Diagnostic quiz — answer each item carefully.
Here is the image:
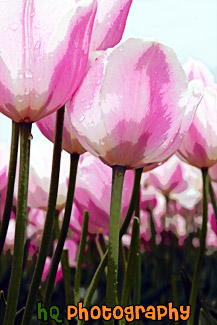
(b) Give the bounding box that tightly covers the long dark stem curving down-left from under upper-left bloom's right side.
[22,106,64,325]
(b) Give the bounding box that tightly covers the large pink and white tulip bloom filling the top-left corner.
[0,0,96,122]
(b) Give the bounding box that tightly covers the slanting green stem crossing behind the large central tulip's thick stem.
[81,168,142,308]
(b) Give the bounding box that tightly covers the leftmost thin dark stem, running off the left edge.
[0,121,19,257]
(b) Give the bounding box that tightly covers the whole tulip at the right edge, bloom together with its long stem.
[178,62,217,325]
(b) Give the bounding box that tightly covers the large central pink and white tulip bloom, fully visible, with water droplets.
[67,39,200,169]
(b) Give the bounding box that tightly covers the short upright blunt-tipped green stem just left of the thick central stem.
[74,210,89,305]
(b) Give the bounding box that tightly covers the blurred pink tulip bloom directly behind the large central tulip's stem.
[73,154,134,233]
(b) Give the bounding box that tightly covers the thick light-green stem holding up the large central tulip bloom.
[106,166,125,316]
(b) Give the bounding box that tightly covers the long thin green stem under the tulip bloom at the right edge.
[188,168,209,325]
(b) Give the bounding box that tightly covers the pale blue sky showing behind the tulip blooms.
[0,0,217,142]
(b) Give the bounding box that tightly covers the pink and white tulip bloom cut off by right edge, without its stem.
[178,62,217,168]
